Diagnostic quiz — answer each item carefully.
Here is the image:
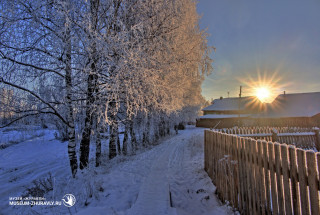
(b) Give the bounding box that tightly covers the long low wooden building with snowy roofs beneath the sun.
[197,92,320,128]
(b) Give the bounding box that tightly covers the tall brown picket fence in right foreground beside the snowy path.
[204,130,320,215]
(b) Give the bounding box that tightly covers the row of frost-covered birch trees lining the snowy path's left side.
[0,0,212,176]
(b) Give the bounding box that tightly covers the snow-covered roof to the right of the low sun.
[257,92,320,118]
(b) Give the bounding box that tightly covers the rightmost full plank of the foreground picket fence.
[306,151,320,214]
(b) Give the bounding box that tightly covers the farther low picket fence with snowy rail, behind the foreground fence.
[216,127,320,152]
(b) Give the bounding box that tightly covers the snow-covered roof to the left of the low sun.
[202,96,260,111]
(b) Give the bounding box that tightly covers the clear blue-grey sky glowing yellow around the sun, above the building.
[197,0,320,100]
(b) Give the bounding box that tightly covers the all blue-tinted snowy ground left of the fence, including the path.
[0,128,233,215]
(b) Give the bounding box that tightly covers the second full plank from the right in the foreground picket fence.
[297,149,309,214]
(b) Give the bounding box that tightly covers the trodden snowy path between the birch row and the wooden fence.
[127,129,231,215]
